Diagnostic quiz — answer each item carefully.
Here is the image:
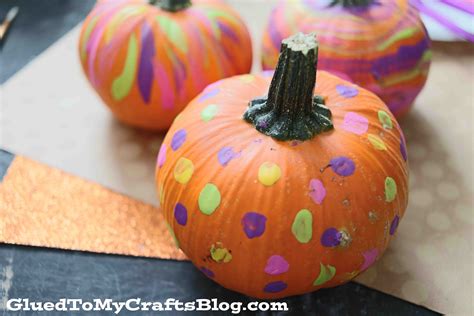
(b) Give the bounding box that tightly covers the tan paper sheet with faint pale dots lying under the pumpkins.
[0,2,474,315]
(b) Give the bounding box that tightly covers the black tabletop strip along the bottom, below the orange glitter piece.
[0,245,436,315]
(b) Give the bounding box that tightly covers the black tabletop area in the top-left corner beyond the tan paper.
[0,0,95,84]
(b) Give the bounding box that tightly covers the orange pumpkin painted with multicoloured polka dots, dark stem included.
[156,33,408,298]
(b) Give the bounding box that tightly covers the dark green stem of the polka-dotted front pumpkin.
[244,33,333,140]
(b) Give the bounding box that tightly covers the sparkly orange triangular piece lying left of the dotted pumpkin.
[0,156,186,260]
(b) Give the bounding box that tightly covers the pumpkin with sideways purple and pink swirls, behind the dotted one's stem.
[262,0,431,117]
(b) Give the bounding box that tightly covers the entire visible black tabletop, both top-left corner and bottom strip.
[0,0,437,315]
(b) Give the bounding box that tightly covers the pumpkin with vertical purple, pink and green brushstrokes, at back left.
[79,0,252,130]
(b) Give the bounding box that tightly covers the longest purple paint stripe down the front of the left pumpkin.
[137,22,155,103]
